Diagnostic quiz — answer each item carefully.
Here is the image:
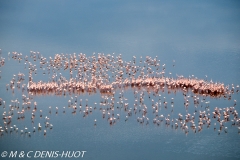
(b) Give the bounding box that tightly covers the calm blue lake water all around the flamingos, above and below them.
[0,1,240,159]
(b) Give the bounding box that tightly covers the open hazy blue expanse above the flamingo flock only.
[0,1,240,83]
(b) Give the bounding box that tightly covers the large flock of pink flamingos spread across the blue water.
[0,51,240,137]
